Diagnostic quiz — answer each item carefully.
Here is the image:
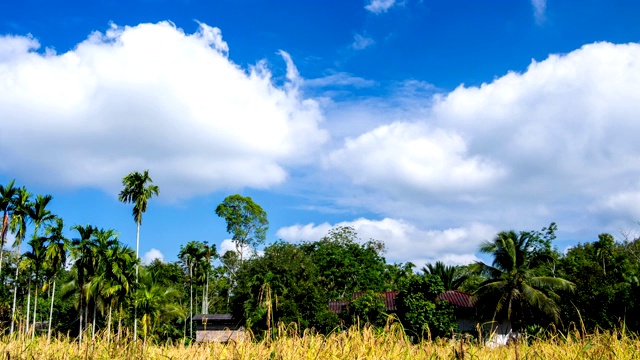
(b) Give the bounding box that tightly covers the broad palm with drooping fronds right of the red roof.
[474,231,574,330]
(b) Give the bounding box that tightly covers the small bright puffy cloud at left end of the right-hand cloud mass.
[326,122,505,197]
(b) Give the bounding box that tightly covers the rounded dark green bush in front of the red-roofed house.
[396,274,457,340]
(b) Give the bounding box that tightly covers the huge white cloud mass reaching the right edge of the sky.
[324,43,640,239]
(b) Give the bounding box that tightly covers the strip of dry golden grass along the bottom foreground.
[0,324,640,360]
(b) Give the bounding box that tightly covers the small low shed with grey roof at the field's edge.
[191,314,244,342]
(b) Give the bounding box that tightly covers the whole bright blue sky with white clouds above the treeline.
[0,0,640,267]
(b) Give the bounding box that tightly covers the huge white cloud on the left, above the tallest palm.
[0,22,328,199]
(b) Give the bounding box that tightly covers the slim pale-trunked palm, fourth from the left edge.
[46,218,68,343]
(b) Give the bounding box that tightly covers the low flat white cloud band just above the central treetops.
[277,218,497,267]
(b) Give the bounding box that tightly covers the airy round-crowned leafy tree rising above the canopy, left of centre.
[216,194,269,263]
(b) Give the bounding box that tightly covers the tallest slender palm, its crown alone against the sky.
[118,170,160,339]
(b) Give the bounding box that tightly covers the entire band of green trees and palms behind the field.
[0,171,640,343]
